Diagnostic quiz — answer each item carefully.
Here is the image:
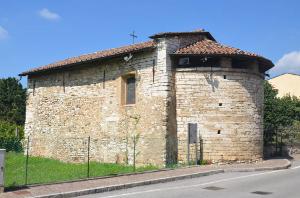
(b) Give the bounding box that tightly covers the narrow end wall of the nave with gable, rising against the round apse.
[156,35,205,164]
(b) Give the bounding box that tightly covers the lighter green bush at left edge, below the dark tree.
[0,120,24,152]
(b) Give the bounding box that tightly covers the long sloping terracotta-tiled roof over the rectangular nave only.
[19,41,156,76]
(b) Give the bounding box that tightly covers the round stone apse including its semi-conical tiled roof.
[173,39,273,162]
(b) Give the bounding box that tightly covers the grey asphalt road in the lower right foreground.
[81,161,300,198]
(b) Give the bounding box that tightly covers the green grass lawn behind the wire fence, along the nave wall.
[4,152,157,187]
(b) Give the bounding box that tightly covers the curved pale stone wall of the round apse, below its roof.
[176,68,263,162]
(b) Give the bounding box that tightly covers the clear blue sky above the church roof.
[0,0,300,84]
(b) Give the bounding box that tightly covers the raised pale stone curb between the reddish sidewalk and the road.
[35,169,224,198]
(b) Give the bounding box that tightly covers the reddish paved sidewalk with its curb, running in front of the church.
[0,159,291,198]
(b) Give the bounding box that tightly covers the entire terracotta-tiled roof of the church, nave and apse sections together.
[19,30,274,76]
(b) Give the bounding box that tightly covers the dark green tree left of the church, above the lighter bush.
[0,78,26,125]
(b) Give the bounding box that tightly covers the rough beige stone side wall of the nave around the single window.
[25,51,171,165]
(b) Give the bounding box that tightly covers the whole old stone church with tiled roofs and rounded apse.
[20,30,273,166]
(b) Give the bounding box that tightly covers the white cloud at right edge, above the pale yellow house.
[270,51,300,75]
